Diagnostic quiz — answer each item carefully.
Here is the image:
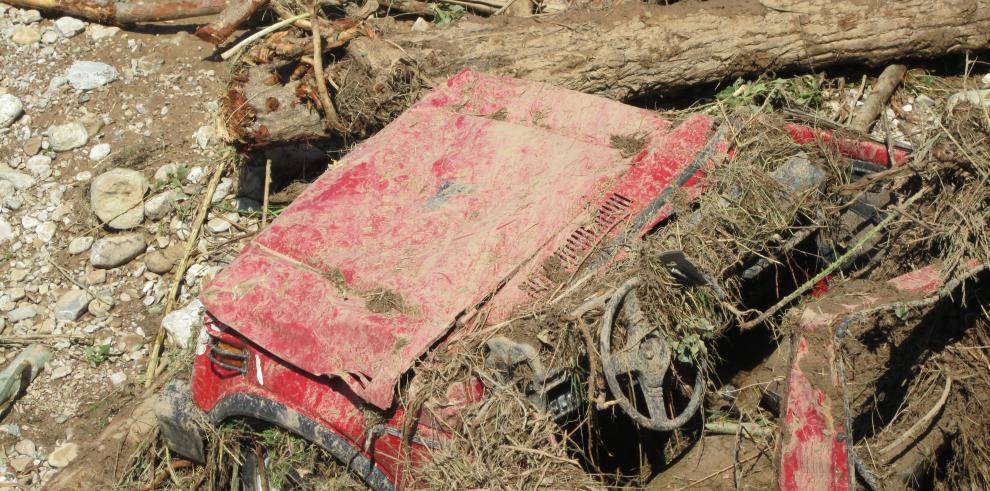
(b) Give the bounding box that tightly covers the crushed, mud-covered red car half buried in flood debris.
[156,70,905,489]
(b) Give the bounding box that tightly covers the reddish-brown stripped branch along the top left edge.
[4,0,227,24]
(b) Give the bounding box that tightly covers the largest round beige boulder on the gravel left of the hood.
[89,168,149,230]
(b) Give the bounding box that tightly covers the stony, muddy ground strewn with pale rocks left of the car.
[0,4,244,487]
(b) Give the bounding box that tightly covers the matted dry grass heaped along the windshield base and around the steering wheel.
[396,109,844,489]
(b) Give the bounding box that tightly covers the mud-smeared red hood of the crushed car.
[201,71,707,407]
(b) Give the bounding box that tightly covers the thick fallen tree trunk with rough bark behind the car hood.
[224,0,990,145]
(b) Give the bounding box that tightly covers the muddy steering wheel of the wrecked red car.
[599,278,705,431]
